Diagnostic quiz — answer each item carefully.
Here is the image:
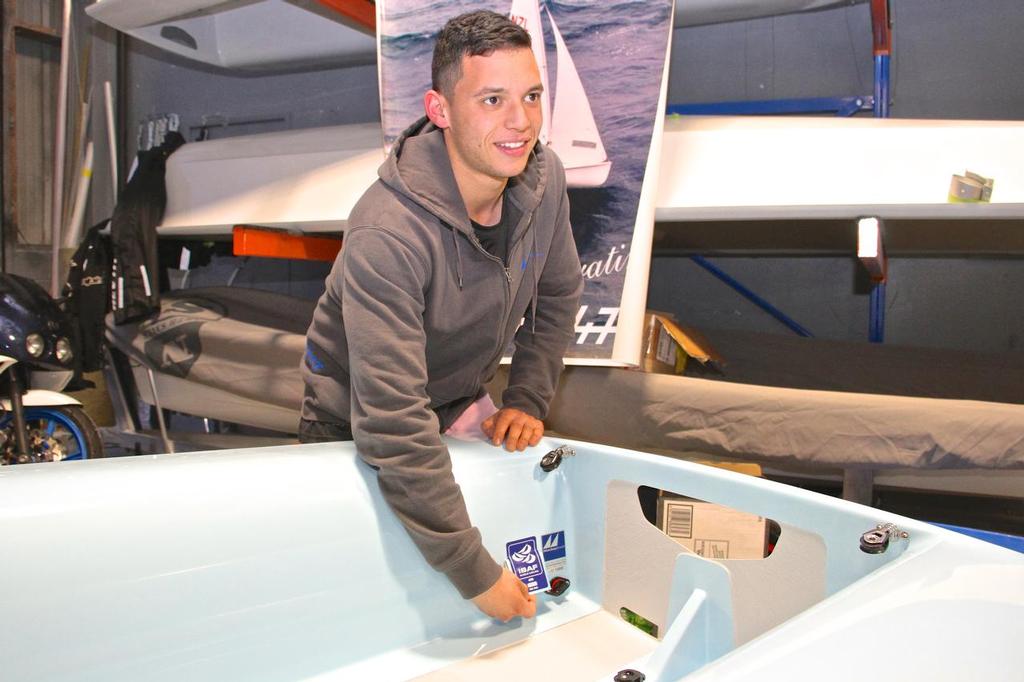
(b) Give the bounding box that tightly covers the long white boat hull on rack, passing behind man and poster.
[149,116,1024,237]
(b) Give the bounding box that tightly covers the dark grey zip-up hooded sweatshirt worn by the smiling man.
[302,118,583,598]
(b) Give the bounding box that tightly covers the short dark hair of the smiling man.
[430,9,530,97]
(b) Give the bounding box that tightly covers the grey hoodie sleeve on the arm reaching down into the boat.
[342,228,502,599]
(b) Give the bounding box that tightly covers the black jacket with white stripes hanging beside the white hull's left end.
[111,132,185,325]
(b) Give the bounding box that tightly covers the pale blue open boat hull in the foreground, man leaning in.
[0,438,1024,682]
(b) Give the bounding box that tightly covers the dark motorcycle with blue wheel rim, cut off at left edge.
[0,273,103,465]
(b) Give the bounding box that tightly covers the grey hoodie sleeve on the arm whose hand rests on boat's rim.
[502,176,583,419]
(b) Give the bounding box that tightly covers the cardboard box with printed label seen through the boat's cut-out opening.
[657,491,768,559]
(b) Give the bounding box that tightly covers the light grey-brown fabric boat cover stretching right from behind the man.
[547,368,1024,469]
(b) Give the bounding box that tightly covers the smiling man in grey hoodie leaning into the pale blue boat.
[299,11,583,621]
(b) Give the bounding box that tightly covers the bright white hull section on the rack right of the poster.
[656,116,1024,222]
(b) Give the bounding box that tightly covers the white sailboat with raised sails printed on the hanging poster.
[509,0,611,187]
